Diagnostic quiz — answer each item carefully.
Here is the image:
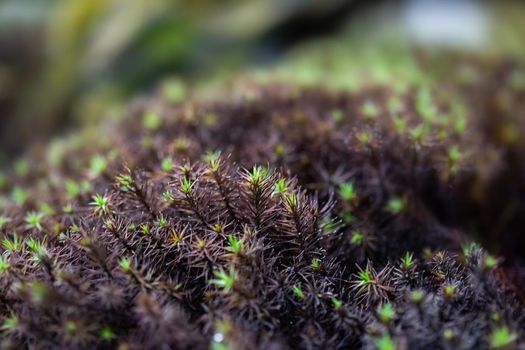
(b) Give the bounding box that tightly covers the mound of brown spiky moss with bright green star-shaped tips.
[0,82,525,349]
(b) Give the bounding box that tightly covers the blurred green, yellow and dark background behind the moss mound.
[0,0,525,161]
